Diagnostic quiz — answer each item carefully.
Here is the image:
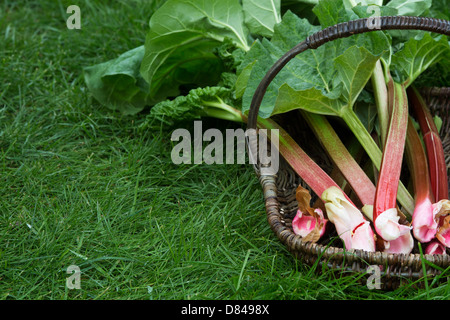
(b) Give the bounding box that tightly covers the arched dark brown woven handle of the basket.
[247,16,450,130]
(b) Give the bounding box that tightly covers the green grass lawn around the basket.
[0,0,450,299]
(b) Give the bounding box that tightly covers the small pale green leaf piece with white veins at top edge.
[242,0,281,38]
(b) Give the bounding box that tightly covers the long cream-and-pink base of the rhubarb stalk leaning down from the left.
[321,187,375,252]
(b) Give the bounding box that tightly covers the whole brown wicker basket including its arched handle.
[248,17,450,290]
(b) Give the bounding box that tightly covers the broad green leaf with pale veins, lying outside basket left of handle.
[141,0,248,99]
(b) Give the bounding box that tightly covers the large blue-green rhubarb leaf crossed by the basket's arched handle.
[236,0,389,118]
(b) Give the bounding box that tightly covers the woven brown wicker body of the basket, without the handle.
[258,88,450,290]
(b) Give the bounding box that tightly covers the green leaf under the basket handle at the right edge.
[390,33,450,87]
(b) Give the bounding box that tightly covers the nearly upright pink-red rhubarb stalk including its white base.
[373,82,413,253]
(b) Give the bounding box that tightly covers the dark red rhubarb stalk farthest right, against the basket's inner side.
[407,87,448,201]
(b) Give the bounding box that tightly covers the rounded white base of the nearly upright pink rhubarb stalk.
[374,208,411,241]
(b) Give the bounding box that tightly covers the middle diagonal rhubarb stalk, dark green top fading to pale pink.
[302,111,376,205]
